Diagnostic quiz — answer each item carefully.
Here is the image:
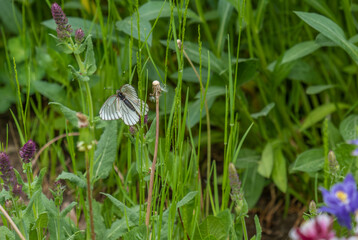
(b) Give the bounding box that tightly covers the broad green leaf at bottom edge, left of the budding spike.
[194,209,232,240]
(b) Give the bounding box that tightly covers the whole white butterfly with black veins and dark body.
[99,84,149,126]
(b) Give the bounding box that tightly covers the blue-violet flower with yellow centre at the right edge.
[319,174,358,229]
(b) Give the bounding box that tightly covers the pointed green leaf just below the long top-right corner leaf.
[267,41,321,71]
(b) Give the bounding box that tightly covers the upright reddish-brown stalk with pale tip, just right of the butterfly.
[145,81,161,229]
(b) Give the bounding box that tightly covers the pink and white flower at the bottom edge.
[289,214,338,240]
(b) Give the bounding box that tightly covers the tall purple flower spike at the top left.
[51,3,72,40]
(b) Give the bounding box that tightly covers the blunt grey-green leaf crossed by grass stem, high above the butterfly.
[116,17,153,46]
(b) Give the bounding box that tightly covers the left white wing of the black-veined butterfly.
[99,95,122,120]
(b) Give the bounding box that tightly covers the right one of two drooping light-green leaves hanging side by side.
[272,148,287,193]
